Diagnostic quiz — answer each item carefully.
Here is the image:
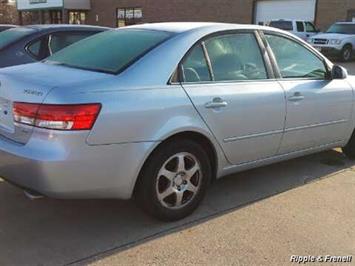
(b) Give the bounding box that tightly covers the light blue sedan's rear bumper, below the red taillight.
[0,129,154,199]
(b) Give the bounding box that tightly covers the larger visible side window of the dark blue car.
[48,32,95,54]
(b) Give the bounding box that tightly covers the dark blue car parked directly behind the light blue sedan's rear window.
[0,25,109,67]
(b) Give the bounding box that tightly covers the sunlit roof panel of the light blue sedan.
[125,22,280,33]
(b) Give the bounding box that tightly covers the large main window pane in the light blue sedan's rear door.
[205,33,267,81]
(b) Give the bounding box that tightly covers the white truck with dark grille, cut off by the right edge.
[308,22,355,62]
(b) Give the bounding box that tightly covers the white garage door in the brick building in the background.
[255,0,316,24]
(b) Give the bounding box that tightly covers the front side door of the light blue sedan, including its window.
[265,33,353,154]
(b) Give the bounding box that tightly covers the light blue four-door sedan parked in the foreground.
[0,23,355,220]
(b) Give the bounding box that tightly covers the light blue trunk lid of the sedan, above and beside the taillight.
[0,63,111,144]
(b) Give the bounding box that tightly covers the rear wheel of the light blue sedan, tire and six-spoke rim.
[135,139,212,221]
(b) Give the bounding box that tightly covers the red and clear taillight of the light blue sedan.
[13,102,101,130]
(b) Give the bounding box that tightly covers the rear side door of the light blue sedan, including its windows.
[180,32,286,164]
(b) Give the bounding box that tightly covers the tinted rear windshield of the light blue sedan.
[46,29,171,74]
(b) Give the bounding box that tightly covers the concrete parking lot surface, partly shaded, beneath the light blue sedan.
[0,63,355,265]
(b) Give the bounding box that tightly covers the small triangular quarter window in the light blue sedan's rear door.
[182,45,211,82]
